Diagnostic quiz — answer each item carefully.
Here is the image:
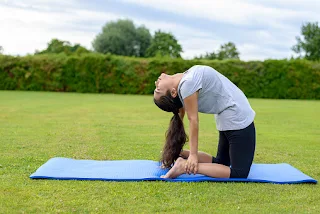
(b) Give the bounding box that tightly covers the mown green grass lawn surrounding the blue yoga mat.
[0,91,320,213]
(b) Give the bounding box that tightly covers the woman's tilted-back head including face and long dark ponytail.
[154,74,187,168]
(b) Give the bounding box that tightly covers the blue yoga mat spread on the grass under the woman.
[30,158,317,184]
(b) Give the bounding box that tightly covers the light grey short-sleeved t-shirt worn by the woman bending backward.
[178,65,255,131]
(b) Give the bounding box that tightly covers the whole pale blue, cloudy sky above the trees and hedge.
[0,0,320,61]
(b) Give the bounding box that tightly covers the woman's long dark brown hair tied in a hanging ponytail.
[154,91,188,168]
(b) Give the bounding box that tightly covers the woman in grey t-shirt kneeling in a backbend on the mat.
[154,65,256,178]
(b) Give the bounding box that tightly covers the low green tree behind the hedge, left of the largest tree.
[35,39,90,55]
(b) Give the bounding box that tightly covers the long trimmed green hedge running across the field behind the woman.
[0,54,320,99]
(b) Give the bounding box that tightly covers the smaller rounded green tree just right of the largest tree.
[147,30,182,58]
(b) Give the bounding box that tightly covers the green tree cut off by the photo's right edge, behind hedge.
[292,22,320,60]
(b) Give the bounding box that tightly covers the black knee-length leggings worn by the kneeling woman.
[212,122,256,178]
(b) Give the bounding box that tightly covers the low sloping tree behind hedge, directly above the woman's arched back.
[196,42,239,60]
